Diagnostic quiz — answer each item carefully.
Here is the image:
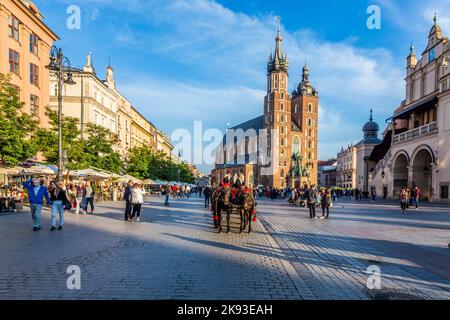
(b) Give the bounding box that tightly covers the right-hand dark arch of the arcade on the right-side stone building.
[412,148,433,200]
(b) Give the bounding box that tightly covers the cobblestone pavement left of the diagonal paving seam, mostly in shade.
[0,198,302,299]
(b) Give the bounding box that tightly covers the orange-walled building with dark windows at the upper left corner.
[0,0,58,127]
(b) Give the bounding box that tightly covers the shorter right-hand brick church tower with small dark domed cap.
[292,62,319,185]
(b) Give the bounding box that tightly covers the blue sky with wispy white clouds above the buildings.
[34,0,450,172]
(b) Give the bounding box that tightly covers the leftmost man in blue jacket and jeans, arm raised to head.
[23,178,51,231]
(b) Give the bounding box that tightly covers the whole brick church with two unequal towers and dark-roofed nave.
[212,26,319,188]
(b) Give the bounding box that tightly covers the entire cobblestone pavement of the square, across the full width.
[0,198,450,299]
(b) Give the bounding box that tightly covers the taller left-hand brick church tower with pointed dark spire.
[260,21,291,188]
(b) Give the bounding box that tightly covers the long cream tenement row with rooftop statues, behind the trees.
[49,53,173,158]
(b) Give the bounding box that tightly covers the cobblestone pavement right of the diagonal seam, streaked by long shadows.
[260,201,450,299]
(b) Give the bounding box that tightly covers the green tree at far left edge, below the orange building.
[0,74,37,166]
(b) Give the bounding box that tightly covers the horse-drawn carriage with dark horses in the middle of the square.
[211,183,256,233]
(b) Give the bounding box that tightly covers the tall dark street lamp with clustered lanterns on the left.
[46,46,76,181]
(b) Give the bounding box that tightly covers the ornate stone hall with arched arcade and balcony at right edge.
[369,16,450,202]
